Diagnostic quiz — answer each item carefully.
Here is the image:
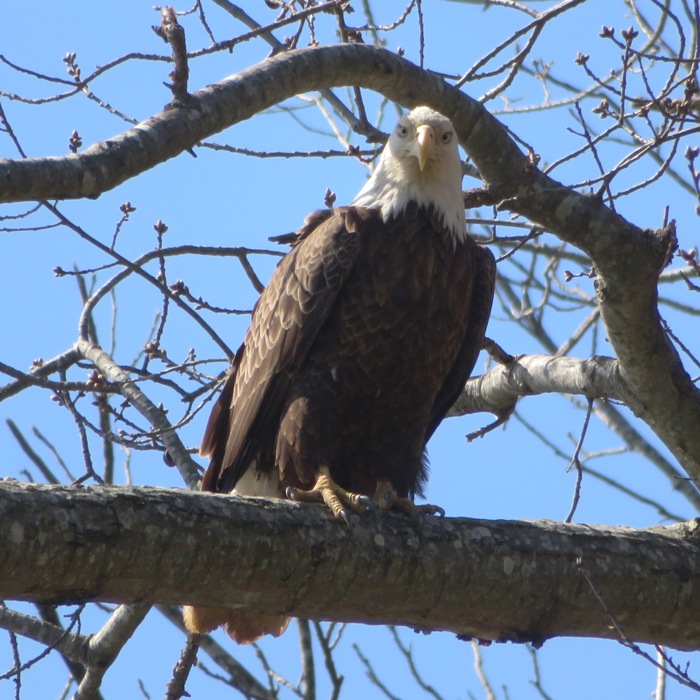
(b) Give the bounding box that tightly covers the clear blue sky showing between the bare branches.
[0,0,700,700]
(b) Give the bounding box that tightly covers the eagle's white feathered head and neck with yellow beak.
[352,107,466,241]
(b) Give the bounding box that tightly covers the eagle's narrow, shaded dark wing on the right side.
[425,239,496,442]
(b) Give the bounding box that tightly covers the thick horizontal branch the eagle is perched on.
[0,481,700,649]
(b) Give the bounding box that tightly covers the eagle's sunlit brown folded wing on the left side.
[200,207,363,493]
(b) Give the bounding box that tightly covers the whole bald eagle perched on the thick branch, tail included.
[185,107,495,643]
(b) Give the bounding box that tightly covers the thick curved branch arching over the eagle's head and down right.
[0,44,700,480]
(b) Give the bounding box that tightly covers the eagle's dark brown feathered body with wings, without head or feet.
[203,206,492,504]
